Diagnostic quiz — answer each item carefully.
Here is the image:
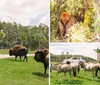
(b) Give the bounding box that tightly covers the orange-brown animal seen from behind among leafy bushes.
[56,12,77,40]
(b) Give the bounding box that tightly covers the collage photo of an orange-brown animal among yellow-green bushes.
[50,0,100,43]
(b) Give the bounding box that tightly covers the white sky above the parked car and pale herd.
[50,43,100,59]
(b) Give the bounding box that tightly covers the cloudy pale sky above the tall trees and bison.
[0,0,50,26]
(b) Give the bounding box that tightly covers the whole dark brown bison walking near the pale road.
[9,45,28,62]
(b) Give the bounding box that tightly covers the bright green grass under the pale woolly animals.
[50,63,100,85]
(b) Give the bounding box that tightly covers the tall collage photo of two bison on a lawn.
[0,0,50,85]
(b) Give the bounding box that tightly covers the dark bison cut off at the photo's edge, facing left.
[34,49,49,74]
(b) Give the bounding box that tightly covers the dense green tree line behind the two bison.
[0,22,49,49]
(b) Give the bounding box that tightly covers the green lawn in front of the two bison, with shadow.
[0,57,48,85]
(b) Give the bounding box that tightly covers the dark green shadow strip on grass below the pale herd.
[55,80,84,85]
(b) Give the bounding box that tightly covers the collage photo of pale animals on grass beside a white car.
[50,43,100,85]
